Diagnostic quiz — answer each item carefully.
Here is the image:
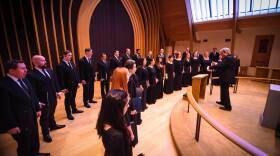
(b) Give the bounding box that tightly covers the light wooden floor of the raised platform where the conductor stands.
[171,80,280,156]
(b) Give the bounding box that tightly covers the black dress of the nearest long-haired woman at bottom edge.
[102,128,132,156]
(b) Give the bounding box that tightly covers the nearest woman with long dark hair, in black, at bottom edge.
[96,89,132,156]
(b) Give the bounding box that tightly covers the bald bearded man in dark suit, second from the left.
[27,55,65,142]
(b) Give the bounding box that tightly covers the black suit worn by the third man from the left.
[57,61,79,115]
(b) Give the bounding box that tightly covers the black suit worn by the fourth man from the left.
[79,57,96,105]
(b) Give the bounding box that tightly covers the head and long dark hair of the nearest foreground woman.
[96,89,129,137]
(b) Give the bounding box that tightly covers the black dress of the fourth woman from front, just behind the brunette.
[136,67,149,111]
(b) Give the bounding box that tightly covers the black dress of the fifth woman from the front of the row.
[147,67,157,104]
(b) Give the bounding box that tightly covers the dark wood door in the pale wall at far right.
[251,35,274,67]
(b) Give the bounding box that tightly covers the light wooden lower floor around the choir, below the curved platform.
[0,83,178,156]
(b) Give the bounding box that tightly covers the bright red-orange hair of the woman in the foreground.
[111,67,129,91]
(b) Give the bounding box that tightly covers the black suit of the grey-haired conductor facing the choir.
[217,55,235,109]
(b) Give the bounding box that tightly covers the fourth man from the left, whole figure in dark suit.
[79,48,96,108]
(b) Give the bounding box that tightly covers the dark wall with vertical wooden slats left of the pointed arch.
[0,0,81,77]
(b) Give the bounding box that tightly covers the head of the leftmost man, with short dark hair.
[6,60,27,79]
